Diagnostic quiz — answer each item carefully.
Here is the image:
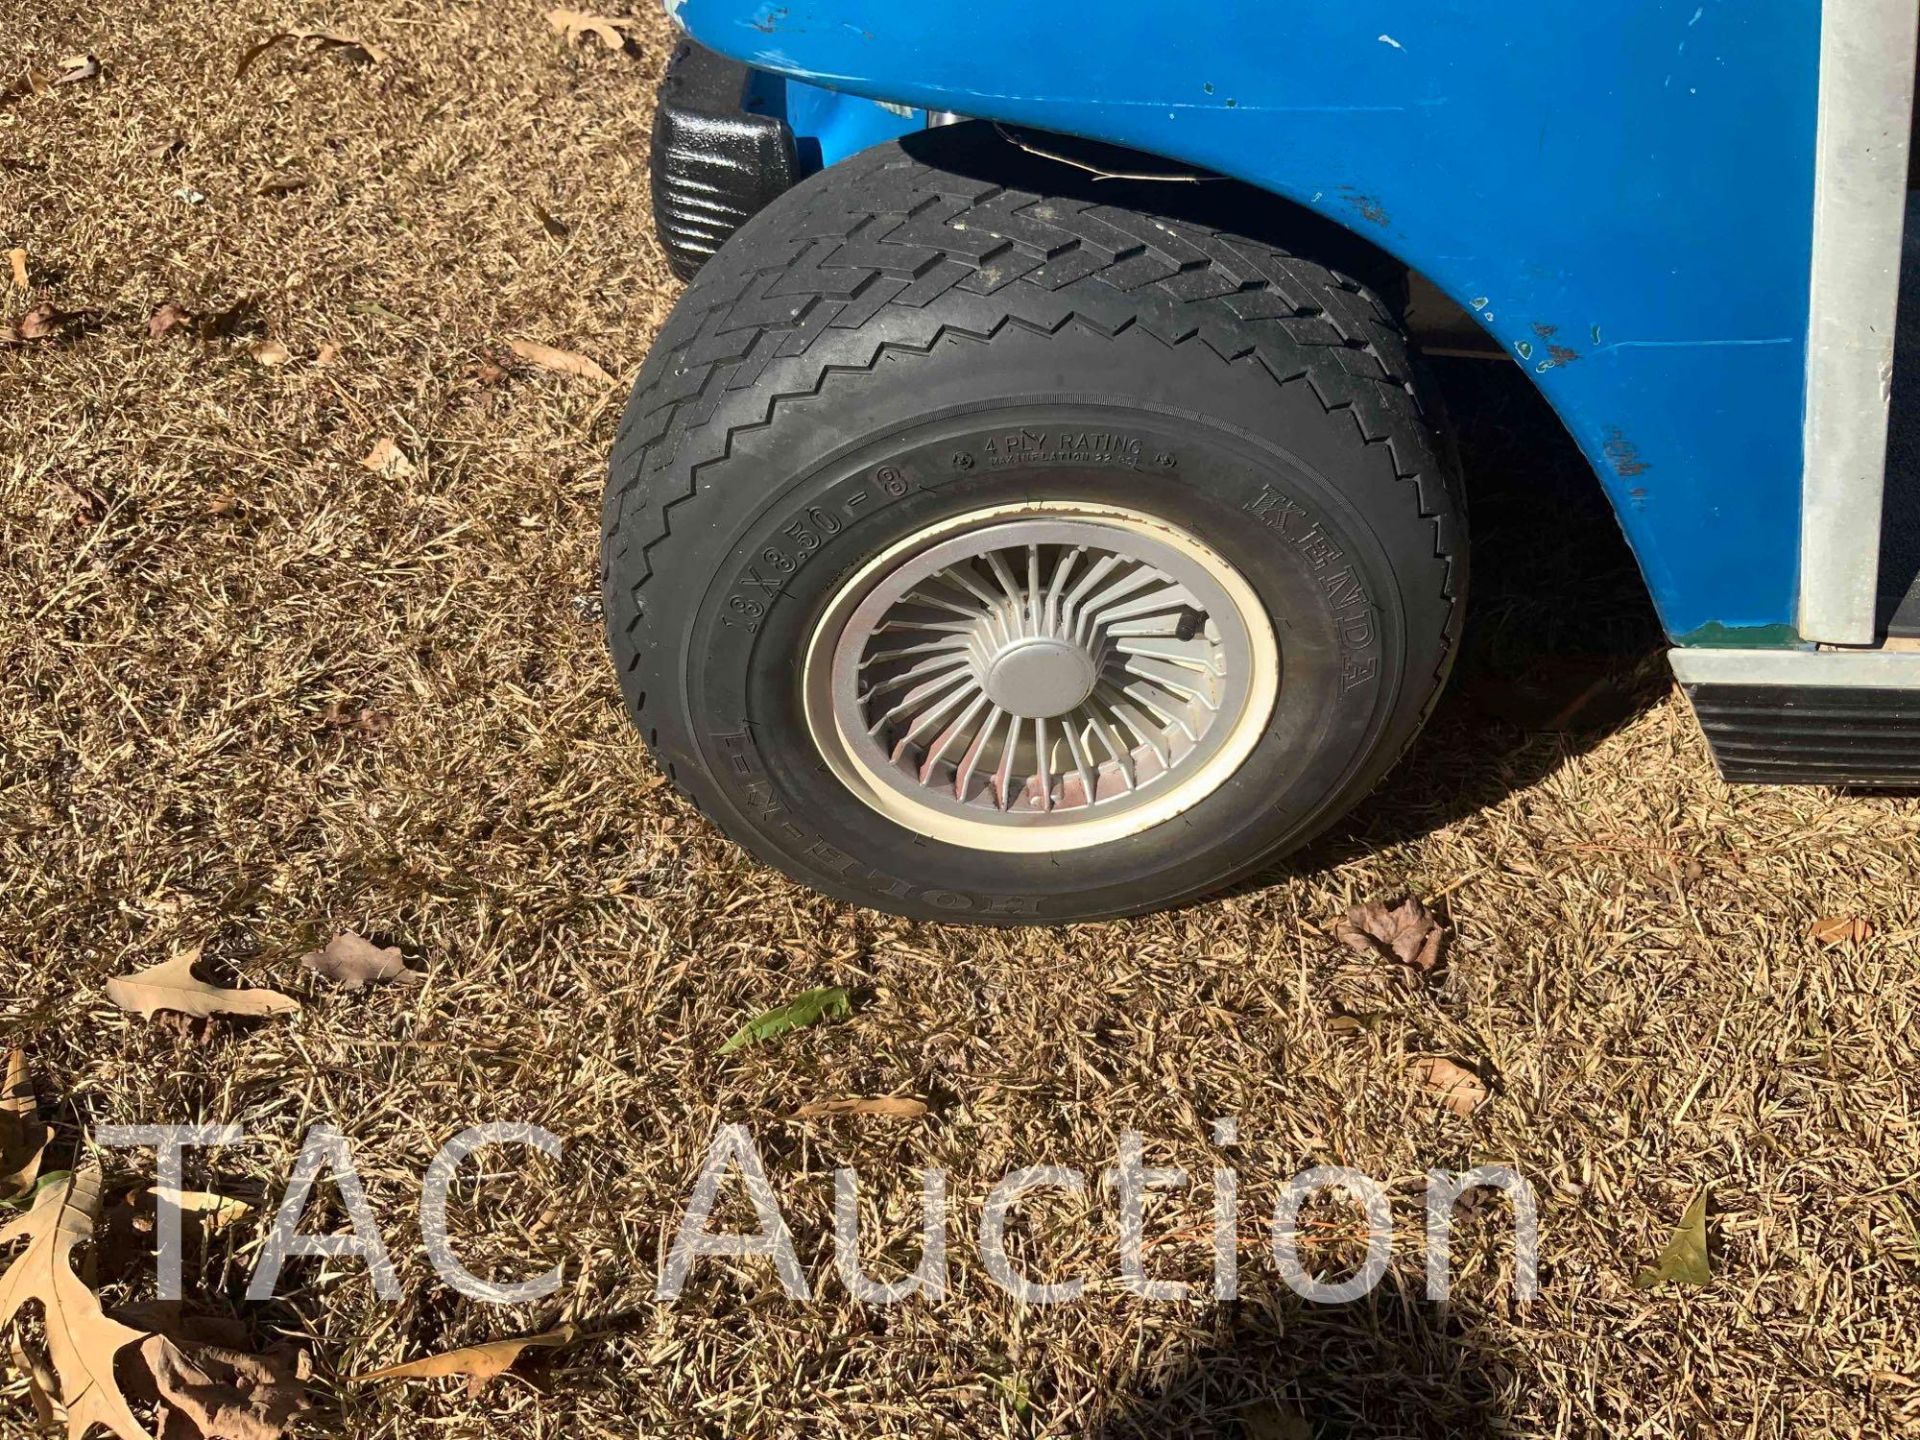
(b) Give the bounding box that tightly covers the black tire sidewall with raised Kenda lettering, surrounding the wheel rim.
[647,338,1430,922]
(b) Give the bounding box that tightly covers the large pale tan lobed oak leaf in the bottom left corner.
[0,1165,152,1440]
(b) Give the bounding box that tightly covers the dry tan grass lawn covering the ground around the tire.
[0,0,1920,1440]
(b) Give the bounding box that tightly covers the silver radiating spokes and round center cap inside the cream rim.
[825,511,1277,849]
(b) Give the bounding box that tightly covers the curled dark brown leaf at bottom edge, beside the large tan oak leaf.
[140,1334,309,1440]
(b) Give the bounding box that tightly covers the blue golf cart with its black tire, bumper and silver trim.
[605,0,1920,924]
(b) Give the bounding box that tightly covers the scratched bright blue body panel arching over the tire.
[680,0,1820,636]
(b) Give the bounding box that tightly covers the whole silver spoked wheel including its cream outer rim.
[804,503,1279,852]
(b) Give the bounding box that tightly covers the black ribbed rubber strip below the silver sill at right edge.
[1686,685,1920,789]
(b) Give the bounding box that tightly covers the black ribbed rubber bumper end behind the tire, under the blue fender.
[653,40,797,280]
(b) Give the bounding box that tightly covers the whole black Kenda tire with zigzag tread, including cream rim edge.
[603,123,1467,924]
